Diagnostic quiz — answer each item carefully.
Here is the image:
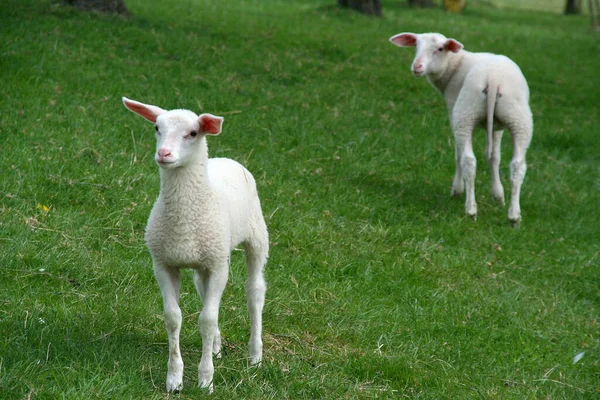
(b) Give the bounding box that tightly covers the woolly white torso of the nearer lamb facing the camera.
[146,158,266,269]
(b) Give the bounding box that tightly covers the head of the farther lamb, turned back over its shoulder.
[390,32,463,77]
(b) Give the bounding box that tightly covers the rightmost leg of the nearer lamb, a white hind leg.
[246,242,268,365]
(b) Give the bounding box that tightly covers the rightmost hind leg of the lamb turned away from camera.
[508,118,533,226]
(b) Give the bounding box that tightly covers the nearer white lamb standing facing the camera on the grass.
[123,97,269,392]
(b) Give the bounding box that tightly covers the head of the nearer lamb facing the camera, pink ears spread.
[123,97,223,169]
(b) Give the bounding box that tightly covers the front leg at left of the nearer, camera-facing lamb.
[154,263,183,392]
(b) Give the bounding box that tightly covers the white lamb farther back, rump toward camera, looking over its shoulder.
[390,33,533,225]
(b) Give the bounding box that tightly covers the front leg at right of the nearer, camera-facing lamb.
[198,261,229,393]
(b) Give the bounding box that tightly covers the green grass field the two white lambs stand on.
[0,0,600,399]
